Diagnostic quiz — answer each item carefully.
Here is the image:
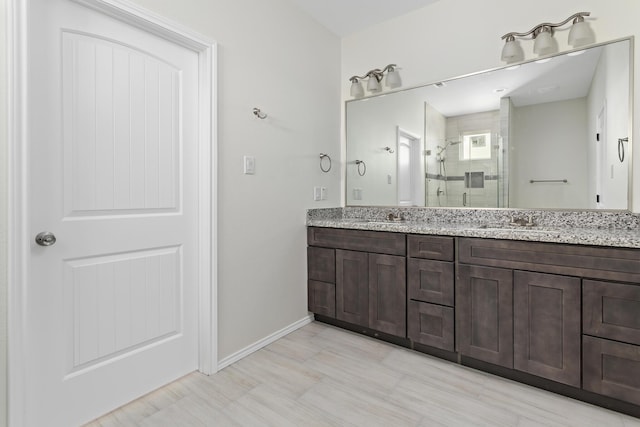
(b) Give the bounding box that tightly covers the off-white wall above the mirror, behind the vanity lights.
[341,0,640,212]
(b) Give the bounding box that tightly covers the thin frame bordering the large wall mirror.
[343,35,635,212]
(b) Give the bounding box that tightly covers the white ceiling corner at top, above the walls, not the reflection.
[289,0,439,37]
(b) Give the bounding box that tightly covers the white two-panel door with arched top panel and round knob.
[13,0,214,426]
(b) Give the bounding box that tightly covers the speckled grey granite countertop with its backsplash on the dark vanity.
[307,207,640,248]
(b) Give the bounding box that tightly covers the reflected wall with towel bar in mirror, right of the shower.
[509,98,591,209]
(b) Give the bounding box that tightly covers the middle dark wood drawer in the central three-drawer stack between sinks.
[407,258,454,306]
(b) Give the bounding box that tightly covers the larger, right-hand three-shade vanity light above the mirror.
[502,12,595,64]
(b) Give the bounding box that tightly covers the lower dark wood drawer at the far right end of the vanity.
[582,335,640,405]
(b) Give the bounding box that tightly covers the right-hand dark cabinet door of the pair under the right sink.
[513,271,581,387]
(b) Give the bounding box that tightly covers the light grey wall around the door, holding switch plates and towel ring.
[0,0,342,425]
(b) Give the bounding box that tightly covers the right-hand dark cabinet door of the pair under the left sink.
[369,254,407,337]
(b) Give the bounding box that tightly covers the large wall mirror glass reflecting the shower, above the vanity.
[346,38,633,210]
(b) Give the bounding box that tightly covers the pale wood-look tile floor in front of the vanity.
[88,322,640,427]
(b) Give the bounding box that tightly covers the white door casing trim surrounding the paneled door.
[6,0,218,426]
